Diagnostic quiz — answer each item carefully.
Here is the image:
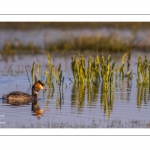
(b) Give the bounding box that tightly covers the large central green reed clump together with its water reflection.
[71,54,115,118]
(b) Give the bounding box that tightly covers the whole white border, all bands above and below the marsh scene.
[0,0,150,150]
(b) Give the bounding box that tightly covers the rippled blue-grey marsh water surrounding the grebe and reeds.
[0,27,150,128]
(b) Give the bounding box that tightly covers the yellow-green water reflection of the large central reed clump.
[71,79,114,118]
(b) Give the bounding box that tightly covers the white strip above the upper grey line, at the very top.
[0,0,149,14]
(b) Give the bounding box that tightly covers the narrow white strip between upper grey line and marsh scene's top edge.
[0,15,150,22]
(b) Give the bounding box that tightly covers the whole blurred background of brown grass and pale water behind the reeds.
[0,22,150,56]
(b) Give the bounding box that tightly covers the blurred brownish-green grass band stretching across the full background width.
[0,33,150,59]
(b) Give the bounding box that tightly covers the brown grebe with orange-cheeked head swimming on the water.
[2,80,46,107]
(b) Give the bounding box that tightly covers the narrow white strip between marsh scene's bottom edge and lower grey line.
[0,128,150,136]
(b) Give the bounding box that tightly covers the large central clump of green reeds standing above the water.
[71,54,115,90]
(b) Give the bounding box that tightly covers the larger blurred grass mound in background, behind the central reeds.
[45,35,132,52]
